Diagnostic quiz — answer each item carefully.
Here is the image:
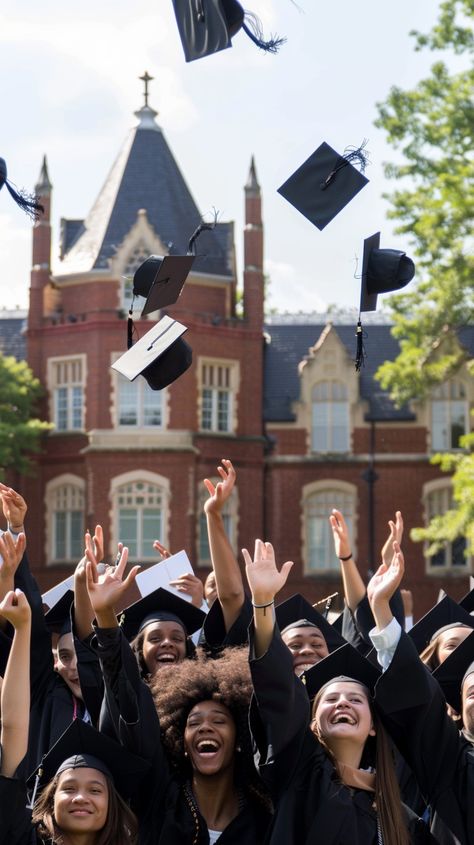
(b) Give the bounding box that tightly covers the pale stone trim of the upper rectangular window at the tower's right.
[197,356,240,435]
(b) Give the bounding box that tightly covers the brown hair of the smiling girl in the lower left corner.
[32,775,138,845]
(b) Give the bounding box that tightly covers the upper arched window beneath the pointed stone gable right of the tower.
[311,381,349,452]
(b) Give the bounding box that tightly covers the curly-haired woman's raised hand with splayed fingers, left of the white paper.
[86,546,140,628]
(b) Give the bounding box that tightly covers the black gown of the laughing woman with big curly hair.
[96,628,270,845]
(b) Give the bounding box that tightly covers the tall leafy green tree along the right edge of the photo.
[377,0,474,554]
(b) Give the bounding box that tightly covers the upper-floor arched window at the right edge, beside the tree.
[431,379,469,451]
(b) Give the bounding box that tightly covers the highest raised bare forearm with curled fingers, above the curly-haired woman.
[204,458,245,631]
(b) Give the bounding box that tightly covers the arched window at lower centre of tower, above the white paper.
[113,471,169,561]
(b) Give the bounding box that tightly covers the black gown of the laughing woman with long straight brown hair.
[250,629,432,845]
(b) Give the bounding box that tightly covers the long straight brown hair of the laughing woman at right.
[313,679,410,845]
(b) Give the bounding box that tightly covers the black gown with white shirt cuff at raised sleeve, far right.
[375,632,474,845]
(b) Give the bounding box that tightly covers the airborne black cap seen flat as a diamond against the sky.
[278,142,369,232]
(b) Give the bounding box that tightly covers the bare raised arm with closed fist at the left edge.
[0,590,31,777]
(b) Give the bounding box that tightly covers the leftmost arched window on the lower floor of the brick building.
[46,475,85,563]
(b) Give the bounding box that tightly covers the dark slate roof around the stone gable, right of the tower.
[263,317,415,422]
